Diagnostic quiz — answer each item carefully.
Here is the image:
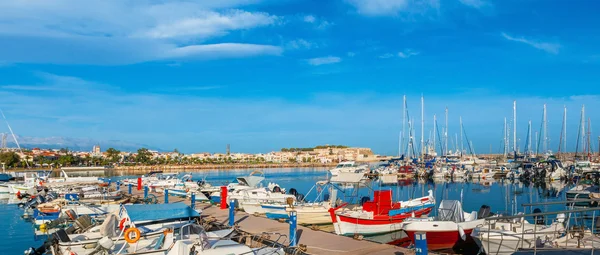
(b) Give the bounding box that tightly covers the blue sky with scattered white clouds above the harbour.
[0,0,600,154]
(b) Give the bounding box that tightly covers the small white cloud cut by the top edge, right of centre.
[347,0,440,16]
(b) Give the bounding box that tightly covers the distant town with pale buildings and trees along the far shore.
[0,145,388,168]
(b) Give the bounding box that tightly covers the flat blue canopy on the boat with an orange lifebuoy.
[120,203,200,222]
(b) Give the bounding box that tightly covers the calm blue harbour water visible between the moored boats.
[0,168,570,254]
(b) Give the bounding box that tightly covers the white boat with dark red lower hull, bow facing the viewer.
[403,200,492,250]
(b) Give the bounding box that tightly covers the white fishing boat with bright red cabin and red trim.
[329,190,435,235]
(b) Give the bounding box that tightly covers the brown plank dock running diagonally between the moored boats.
[128,187,415,255]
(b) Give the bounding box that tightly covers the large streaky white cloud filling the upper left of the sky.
[0,0,282,65]
